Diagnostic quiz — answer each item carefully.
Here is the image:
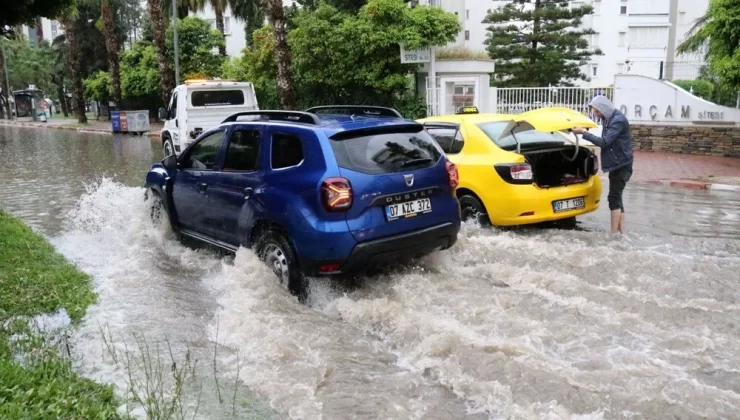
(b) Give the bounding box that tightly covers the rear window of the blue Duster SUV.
[331,130,442,174]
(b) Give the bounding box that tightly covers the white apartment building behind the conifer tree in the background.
[416,0,709,87]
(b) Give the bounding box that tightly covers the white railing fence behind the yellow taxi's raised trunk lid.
[490,86,614,115]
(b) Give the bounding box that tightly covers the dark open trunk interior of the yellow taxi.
[522,145,598,188]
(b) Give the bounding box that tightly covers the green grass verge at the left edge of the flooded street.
[0,211,125,419]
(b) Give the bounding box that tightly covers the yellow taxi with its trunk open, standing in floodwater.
[419,107,601,226]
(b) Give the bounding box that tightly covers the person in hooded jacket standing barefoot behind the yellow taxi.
[573,95,634,233]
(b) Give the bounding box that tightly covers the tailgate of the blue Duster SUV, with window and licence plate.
[330,123,452,242]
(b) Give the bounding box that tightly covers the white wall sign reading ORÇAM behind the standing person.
[614,75,740,125]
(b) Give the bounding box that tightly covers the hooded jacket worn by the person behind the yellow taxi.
[583,95,633,172]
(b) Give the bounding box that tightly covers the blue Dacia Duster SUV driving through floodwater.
[146,106,460,299]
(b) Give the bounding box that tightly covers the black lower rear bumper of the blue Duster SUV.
[301,223,460,275]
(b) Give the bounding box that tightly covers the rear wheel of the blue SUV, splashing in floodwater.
[256,230,308,303]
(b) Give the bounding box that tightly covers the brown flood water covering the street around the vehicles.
[0,126,740,419]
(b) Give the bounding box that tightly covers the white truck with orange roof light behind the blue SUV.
[159,79,259,157]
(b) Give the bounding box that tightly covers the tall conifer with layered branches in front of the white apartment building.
[483,0,601,87]
